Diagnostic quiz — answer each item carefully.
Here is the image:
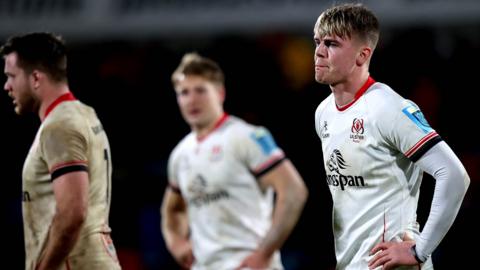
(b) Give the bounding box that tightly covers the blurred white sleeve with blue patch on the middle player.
[235,127,285,177]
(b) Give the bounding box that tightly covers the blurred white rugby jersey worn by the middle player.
[168,114,285,270]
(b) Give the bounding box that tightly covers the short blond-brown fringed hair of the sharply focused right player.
[314,3,380,49]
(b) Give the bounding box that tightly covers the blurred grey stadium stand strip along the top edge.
[0,0,480,40]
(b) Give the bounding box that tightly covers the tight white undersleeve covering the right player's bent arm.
[416,142,470,261]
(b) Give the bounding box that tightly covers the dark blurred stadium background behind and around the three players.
[0,0,480,270]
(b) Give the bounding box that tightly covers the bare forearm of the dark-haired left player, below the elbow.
[37,213,85,270]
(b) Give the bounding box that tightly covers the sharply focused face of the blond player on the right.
[314,33,359,85]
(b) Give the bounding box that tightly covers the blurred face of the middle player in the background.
[175,75,224,130]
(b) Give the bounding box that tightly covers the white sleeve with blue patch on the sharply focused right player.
[380,100,442,162]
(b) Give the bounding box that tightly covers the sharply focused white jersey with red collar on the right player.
[315,78,441,270]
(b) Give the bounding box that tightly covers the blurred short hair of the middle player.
[172,52,225,86]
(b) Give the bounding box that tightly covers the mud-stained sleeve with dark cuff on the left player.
[40,121,88,181]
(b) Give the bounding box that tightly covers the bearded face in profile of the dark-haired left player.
[4,53,39,115]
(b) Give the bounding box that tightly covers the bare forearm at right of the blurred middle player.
[259,182,308,256]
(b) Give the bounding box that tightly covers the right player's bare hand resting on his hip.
[368,241,418,270]
